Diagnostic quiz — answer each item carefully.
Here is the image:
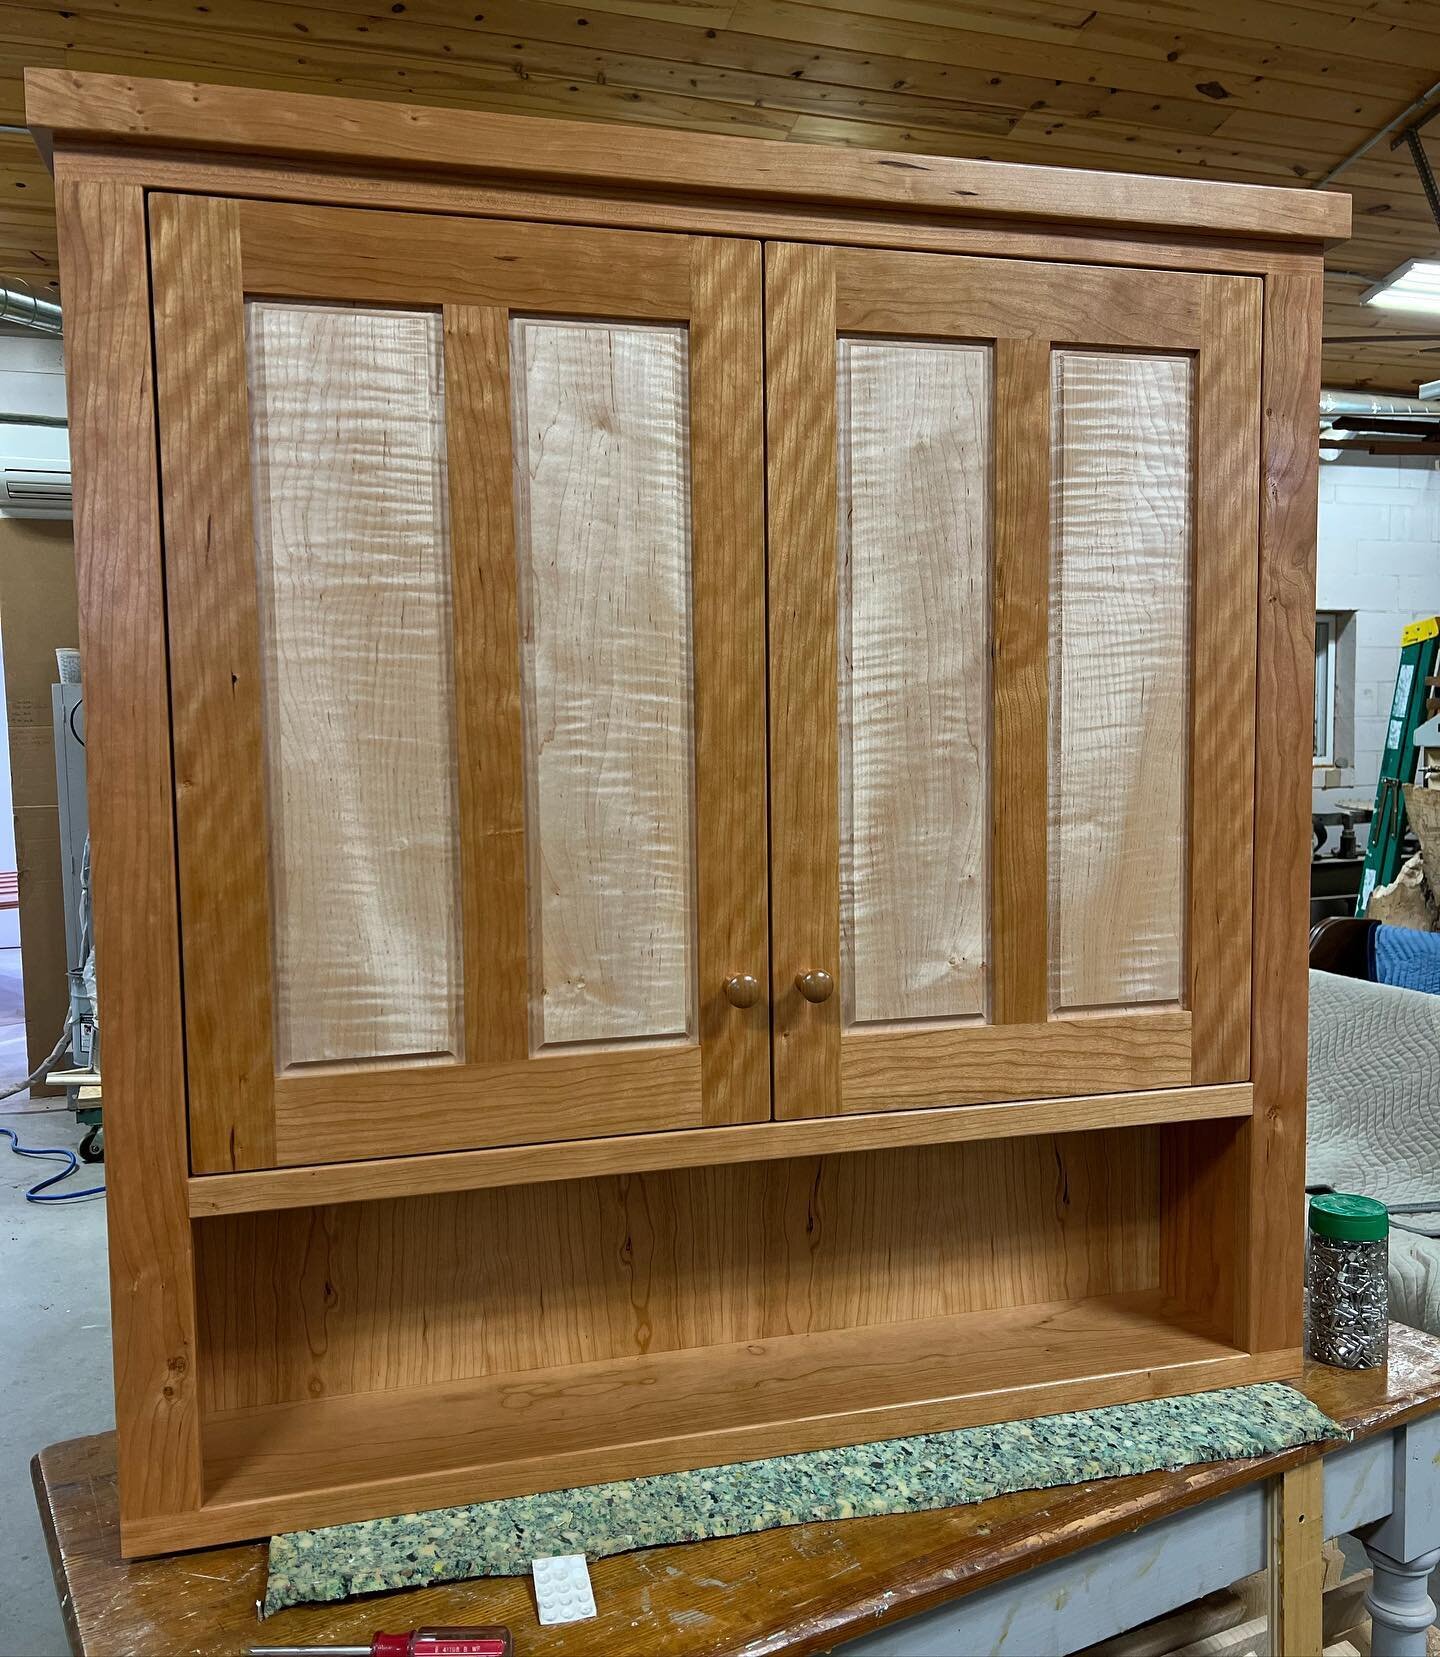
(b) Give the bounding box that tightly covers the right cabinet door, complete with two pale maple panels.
[766,245,1261,1117]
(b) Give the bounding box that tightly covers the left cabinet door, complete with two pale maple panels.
[151,197,769,1171]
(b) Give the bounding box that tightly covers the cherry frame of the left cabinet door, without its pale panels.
[149,194,771,1173]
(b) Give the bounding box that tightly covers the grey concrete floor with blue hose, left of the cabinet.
[0,949,114,1657]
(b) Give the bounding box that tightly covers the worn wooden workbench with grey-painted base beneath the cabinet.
[35,1326,1440,1657]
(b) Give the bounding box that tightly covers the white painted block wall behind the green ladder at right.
[1314,456,1440,809]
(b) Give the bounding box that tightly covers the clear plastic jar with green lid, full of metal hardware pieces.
[1306,1191,1390,1369]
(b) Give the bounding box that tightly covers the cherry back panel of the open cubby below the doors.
[196,1128,1158,1410]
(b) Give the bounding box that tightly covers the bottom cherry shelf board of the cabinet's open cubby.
[124,1289,1299,1553]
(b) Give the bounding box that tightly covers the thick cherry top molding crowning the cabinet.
[25,70,1351,244]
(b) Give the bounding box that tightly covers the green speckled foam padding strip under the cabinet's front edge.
[265,1382,1341,1614]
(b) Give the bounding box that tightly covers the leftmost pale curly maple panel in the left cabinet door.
[245,302,462,1069]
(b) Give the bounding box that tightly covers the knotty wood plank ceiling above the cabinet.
[0,0,1440,391]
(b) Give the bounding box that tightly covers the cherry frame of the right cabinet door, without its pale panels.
[766,244,1261,1118]
